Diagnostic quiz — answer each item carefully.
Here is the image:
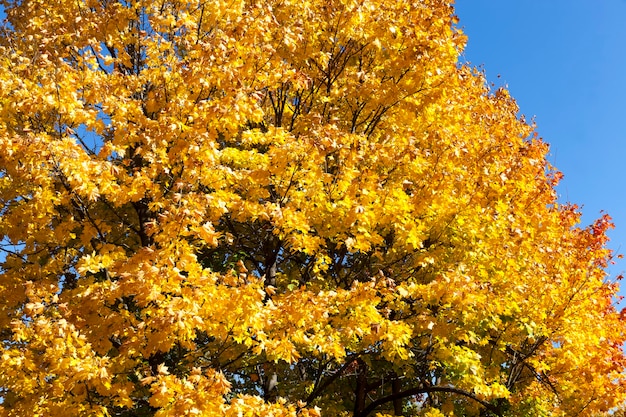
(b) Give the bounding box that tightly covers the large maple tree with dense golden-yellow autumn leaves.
[0,0,626,417]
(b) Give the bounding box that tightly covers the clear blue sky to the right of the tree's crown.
[456,0,626,282]
